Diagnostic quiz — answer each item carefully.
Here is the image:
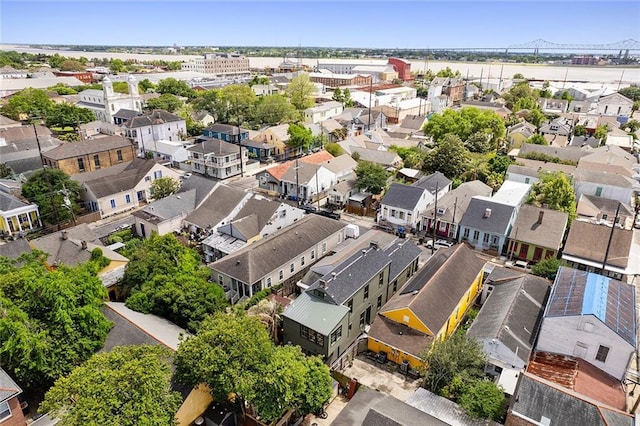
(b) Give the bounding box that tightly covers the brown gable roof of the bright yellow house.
[380,244,485,334]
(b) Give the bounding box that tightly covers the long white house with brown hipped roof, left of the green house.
[210,214,346,303]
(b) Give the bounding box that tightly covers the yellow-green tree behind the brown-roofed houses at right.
[527,172,576,223]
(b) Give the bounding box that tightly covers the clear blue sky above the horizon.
[0,0,640,49]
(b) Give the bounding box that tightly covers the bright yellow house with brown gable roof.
[367,244,485,368]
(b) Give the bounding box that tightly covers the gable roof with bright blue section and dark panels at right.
[544,266,636,348]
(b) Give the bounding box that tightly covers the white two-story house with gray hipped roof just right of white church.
[122,109,187,147]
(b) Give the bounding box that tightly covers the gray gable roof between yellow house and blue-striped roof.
[467,274,551,362]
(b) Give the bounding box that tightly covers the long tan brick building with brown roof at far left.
[42,136,136,175]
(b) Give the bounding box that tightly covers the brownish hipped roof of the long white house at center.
[211,214,346,284]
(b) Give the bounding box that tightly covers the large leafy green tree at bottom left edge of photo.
[42,345,182,426]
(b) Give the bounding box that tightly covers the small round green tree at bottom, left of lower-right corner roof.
[457,379,507,421]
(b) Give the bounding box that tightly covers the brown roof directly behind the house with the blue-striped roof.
[563,220,633,269]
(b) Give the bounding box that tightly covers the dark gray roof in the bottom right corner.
[511,373,635,426]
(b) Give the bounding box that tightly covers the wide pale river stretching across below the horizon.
[0,45,640,85]
